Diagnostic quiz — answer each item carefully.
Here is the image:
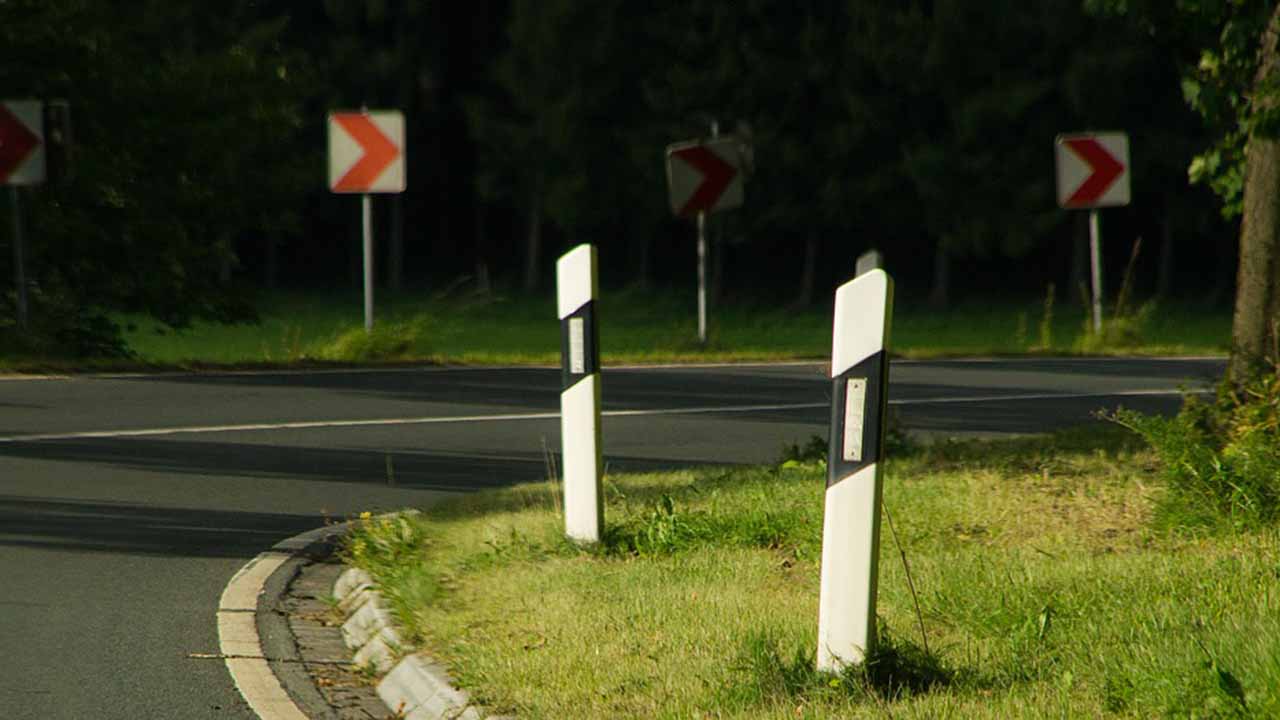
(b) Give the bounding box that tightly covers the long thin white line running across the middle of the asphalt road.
[0,388,1212,443]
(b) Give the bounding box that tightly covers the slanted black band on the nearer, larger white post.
[827,351,888,488]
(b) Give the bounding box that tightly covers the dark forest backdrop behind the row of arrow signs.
[0,0,1239,350]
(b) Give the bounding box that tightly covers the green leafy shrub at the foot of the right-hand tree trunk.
[1107,366,1280,529]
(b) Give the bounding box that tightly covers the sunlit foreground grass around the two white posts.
[347,428,1280,720]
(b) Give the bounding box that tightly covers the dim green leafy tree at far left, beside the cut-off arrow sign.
[0,0,314,352]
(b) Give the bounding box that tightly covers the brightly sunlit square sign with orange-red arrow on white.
[329,110,404,192]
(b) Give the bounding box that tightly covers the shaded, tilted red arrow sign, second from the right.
[667,137,742,218]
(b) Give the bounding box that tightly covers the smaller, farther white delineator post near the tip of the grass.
[556,245,604,542]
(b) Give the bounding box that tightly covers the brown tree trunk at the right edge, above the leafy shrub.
[1228,5,1280,384]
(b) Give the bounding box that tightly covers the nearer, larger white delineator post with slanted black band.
[818,269,893,671]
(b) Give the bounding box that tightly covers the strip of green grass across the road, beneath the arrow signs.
[97,284,1230,366]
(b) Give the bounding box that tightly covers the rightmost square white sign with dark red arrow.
[1055,132,1129,208]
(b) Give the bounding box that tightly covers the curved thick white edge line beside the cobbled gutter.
[218,552,307,720]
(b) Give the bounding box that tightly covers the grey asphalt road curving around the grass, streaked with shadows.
[0,360,1224,720]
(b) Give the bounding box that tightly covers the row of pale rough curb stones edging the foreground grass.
[333,568,515,720]
